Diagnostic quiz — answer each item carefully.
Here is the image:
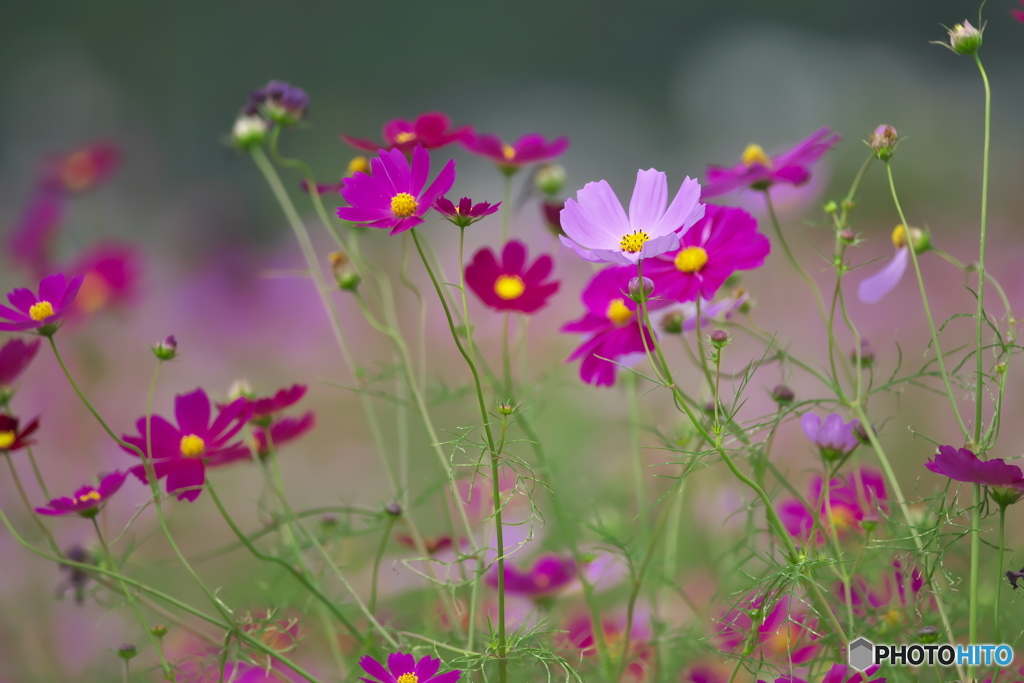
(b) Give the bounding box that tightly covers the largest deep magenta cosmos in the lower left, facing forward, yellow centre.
[122,389,252,502]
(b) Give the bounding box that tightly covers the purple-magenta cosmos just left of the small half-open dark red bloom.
[338,146,455,234]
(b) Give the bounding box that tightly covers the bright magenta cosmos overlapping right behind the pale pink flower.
[643,204,771,301]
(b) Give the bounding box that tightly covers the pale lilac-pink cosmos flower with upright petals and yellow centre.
[559,169,705,266]
